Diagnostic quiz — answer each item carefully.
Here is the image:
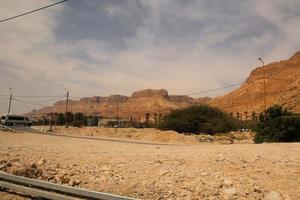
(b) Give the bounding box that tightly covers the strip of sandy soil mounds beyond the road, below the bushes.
[35,126,254,144]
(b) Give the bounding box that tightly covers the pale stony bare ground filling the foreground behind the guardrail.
[0,132,300,200]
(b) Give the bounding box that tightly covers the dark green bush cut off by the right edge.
[254,105,300,143]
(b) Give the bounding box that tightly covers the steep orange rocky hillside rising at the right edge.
[210,52,300,118]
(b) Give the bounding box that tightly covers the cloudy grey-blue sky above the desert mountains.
[0,0,300,113]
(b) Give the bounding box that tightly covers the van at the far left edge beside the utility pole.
[0,114,32,126]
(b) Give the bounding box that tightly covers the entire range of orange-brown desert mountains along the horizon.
[30,52,300,119]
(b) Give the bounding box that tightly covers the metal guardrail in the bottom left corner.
[0,171,133,200]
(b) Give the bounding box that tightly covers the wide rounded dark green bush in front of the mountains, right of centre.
[158,105,236,134]
